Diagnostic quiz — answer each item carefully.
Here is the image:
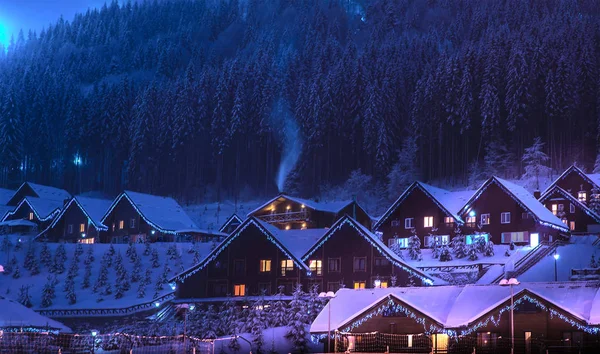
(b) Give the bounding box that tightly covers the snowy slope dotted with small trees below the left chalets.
[0,237,213,309]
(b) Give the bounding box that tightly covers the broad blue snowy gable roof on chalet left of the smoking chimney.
[101,191,198,233]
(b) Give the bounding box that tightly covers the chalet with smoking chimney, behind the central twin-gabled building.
[248,194,371,230]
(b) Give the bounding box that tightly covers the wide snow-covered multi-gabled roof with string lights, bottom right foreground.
[310,282,600,333]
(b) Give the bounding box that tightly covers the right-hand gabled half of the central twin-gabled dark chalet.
[302,215,433,291]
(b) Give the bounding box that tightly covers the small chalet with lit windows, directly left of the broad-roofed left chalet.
[38,196,111,243]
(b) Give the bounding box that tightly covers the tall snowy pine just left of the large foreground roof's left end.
[286,284,309,353]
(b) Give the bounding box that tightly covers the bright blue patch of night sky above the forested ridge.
[0,0,105,44]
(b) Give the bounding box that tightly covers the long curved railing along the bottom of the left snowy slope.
[36,293,175,318]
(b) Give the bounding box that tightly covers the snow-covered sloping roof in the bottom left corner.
[0,296,71,333]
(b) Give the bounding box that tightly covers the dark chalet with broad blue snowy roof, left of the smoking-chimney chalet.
[100,191,197,243]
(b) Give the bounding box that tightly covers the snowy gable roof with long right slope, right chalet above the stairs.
[460,176,569,232]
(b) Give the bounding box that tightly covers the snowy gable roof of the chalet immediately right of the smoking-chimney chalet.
[373,181,474,230]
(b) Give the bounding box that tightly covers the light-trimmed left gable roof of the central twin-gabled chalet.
[170,217,309,281]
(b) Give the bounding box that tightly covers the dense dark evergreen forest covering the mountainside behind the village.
[0,0,600,201]
